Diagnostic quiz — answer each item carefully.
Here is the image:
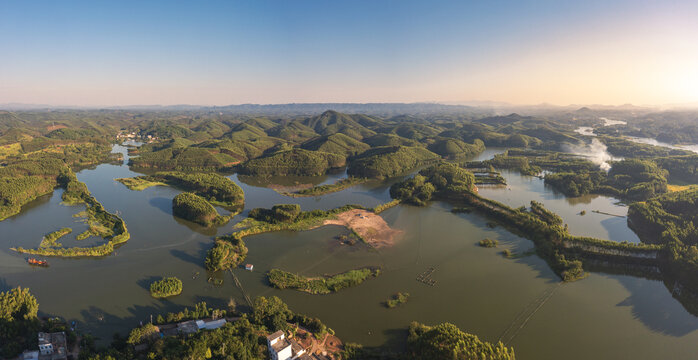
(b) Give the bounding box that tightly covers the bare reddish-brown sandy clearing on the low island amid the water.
[323,209,403,248]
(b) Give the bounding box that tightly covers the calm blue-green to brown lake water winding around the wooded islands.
[0,146,698,359]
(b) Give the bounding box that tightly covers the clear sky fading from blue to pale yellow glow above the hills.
[0,0,698,106]
